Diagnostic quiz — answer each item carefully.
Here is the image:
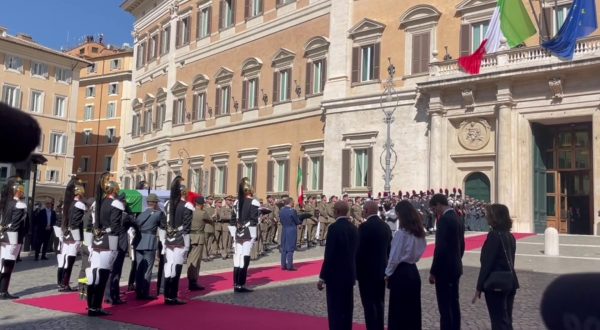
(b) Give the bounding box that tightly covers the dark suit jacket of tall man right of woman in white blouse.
[429,210,465,281]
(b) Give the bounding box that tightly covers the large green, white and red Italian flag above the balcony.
[458,0,536,74]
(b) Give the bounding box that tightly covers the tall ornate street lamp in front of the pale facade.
[379,57,400,196]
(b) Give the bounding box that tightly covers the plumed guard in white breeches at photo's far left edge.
[0,177,27,300]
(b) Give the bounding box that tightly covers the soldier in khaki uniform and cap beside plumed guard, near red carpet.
[187,196,210,291]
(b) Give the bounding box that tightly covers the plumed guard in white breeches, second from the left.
[58,178,87,292]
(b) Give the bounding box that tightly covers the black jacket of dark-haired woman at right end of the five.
[477,230,519,291]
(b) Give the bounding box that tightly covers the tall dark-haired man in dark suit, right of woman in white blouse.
[429,194,465,330]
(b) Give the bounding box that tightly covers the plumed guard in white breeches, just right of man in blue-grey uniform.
[159,176,194,305]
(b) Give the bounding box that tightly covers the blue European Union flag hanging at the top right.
[542,0,598,60]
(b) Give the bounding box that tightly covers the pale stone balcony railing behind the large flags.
[429,36,600,81]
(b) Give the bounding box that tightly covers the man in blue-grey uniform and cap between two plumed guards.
[135,194,166,300]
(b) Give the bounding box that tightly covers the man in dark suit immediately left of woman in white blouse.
[356,201,392,330]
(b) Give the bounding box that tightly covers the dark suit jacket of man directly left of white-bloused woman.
[356,215,392,282]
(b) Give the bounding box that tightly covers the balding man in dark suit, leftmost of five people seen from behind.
[317,201,358,330]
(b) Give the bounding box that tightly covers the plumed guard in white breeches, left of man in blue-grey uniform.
[87,172,120,316]
